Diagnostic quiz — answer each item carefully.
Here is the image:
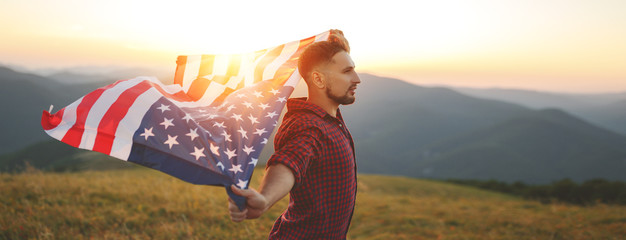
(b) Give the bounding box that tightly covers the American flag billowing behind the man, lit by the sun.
[41,31,330,208]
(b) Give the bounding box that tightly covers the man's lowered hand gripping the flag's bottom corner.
[228,185,268,222]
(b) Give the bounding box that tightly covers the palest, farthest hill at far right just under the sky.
[455,88,626,135]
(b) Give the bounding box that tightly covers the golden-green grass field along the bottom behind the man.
[0,169,626,240]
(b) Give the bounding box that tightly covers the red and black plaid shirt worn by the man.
[267,99,357,239]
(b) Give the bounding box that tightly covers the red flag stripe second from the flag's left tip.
[61,81,122,147]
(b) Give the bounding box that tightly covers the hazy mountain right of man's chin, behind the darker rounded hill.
[342,74,530,176]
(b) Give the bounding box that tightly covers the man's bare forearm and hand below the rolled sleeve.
[228,164,295,222]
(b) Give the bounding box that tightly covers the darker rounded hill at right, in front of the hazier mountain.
[412,110,626,183]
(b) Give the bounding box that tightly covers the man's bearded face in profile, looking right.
[323,51,361,105]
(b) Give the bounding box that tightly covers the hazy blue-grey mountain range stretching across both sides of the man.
[0,68,626,183]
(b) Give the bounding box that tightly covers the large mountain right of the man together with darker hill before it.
[342,74,626,183]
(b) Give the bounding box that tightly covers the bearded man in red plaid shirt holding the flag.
[229,30,361,239]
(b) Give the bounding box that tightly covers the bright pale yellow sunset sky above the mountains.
[0,0,626,93]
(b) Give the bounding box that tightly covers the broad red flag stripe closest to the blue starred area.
[92,81,151,154]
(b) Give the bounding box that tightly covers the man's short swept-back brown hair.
[298,30,350,82]
